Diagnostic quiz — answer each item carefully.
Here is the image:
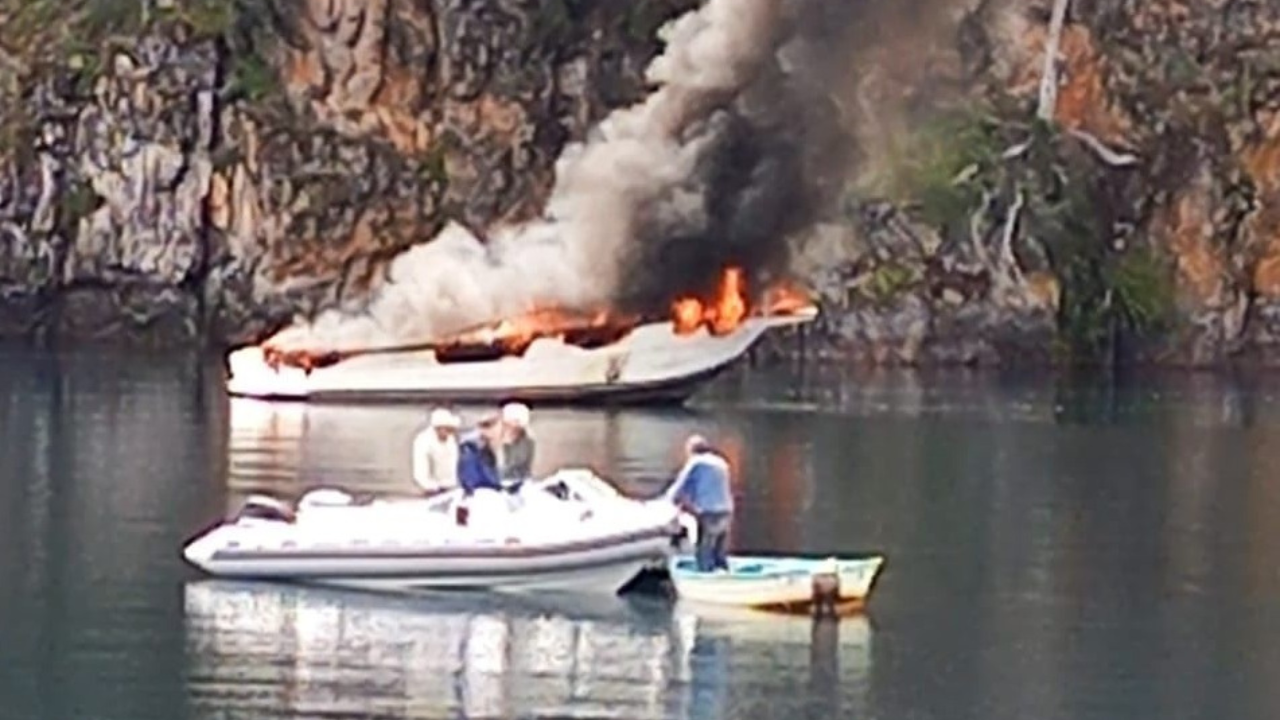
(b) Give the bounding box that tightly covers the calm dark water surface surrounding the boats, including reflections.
[0,351,1280,720]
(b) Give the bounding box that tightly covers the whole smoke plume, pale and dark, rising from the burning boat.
[269,0,951,351]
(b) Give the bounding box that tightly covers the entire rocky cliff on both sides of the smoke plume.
[0,0,1280,365]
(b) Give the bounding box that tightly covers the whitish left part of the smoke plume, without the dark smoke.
[269,0,781,350]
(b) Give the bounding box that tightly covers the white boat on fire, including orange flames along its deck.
[227,268,818,402]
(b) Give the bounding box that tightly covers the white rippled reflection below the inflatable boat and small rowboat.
[183,580,870,719]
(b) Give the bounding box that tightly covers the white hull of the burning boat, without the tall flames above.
[227,306,818,404]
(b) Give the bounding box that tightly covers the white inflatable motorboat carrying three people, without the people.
[183,470,686,593]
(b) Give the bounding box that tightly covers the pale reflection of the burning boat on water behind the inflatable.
[227,398,817,551]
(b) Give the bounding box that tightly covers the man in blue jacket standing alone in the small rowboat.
[667,436,733,573]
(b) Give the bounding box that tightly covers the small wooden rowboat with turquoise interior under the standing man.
[668,555,884,615]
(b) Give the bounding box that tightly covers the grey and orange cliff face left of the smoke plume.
[0,0,691,343]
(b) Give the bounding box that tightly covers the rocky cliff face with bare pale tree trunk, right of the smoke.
[800,0,1280,366]
